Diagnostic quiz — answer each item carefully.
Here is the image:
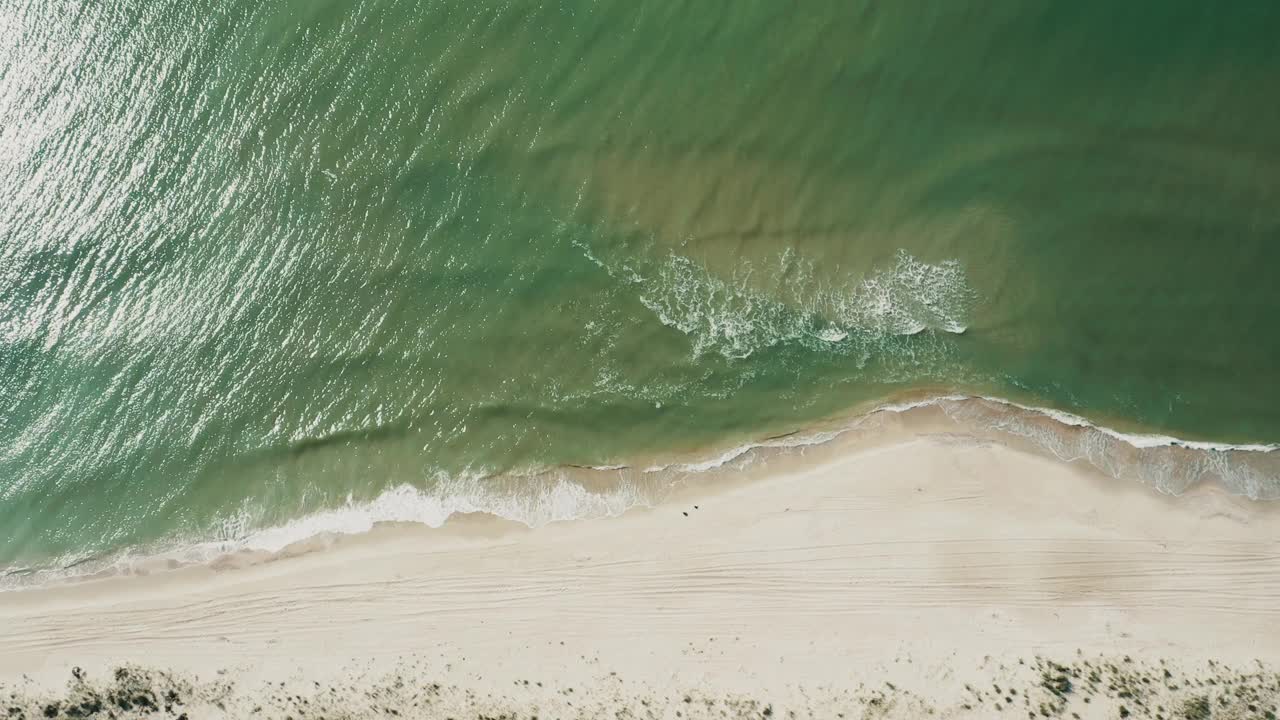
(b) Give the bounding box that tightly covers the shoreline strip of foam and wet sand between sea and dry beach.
[0,388,1280,594]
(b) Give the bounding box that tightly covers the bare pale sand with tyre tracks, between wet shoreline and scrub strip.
[0,442,1280,682]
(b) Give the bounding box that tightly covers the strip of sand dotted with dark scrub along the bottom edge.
[0,656,1280,720]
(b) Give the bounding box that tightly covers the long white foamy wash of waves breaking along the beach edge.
[0,395,1280,591]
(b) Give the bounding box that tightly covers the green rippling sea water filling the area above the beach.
[0,0,1280,569]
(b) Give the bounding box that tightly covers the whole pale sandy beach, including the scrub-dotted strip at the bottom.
[0,420,1280,717]
